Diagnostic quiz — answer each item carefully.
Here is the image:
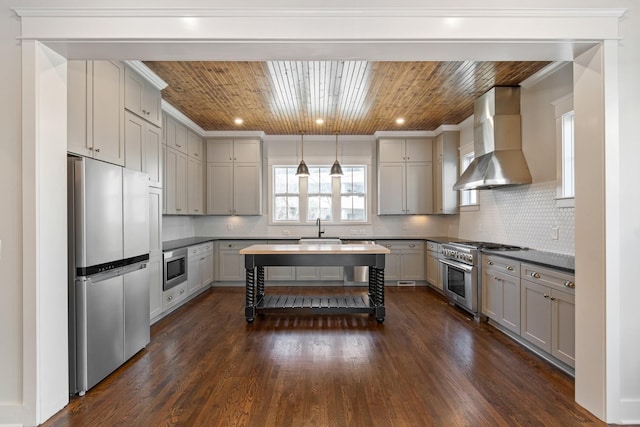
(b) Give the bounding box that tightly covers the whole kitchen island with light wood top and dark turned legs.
[240,244,390,323]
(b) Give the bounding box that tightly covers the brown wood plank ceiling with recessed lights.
[145,61,548,135]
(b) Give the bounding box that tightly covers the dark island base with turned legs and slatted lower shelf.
[245,254,385,323]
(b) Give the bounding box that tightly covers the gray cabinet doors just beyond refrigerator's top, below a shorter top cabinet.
[124,111,162,187]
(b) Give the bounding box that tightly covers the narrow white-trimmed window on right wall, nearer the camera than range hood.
[552,94,575,208]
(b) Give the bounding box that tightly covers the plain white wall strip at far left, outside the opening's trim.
[0,0,22,424]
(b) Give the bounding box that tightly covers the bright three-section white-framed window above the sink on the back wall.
[272,165,367,224]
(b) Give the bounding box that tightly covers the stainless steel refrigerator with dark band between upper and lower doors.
[67,156,150,395]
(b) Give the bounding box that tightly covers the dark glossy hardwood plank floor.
[44,287,605,426]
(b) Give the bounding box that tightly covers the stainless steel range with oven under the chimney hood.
[438,242,523,320]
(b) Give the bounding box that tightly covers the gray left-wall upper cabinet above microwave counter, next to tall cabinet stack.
[163,146,188,215]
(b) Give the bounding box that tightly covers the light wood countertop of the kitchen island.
[240,244,391,255]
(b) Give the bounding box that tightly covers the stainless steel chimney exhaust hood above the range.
[453,86,531,190]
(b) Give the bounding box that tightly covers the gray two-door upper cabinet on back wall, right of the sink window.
[378,138,433,215]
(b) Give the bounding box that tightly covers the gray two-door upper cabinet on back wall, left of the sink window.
[206,139,262,215]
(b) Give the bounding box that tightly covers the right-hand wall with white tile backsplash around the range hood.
[450,64,575,255]
